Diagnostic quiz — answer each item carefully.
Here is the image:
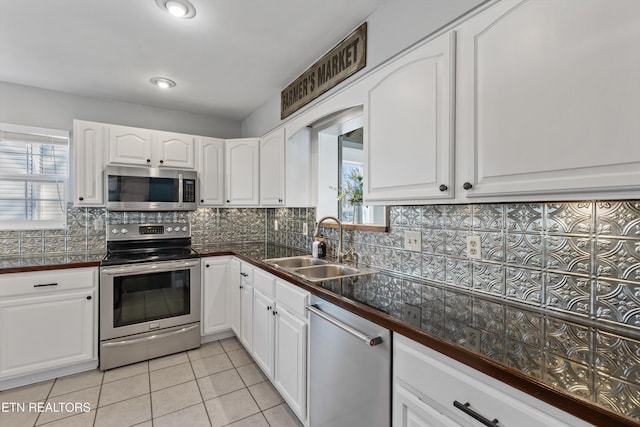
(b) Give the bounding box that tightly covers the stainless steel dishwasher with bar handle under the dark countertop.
[308,296,391,427]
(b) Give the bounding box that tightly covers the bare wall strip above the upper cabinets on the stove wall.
[0,82,241,138]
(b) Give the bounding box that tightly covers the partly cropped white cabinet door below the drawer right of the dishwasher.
[392,385,460,427]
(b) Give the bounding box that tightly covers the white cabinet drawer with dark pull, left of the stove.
[0,268,97,297]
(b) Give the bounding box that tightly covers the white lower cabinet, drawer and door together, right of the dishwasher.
[393,334,589,427]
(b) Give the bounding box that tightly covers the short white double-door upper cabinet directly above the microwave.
[108,125,195,169]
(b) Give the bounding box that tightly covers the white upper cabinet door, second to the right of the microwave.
[225,138,260,206]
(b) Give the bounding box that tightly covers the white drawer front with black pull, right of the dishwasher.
[394,336,568,427]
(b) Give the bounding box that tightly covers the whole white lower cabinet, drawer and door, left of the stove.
[0,268,98,388]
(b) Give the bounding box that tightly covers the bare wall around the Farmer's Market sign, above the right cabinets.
[242,0,487,137]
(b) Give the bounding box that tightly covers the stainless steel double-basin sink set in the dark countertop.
[264,256,378,282]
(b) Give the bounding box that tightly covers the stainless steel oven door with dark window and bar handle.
[100,259,200,340]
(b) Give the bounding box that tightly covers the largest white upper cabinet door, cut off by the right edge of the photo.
[457,0,640,201]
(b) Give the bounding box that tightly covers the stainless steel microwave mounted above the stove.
[104,166,198,211]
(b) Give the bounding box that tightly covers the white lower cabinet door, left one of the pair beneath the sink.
[252,288,275,379]
